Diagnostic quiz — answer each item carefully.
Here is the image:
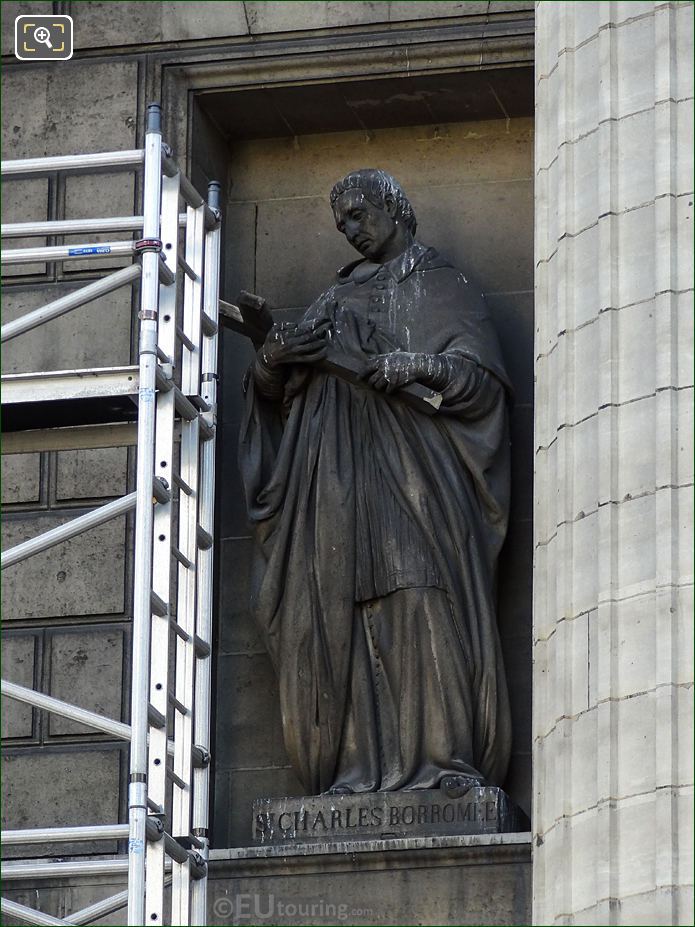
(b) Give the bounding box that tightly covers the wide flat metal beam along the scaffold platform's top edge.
[0,365,140,406]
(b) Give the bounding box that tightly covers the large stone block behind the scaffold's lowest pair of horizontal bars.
[2,747,123,857]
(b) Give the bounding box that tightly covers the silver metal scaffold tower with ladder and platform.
[1,104,220,925]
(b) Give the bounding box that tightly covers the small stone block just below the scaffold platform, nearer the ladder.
[55,447,128,501]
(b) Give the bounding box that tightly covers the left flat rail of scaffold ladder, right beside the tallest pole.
[145,174,179,925]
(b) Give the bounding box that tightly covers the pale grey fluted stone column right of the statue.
[533,2,693,925]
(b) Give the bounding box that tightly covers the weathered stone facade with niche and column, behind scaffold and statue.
[2,0,693,924]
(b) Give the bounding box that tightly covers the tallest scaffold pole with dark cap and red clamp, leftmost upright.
[128,103,162,927]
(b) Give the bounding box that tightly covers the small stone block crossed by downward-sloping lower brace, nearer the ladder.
[48,628,123,737]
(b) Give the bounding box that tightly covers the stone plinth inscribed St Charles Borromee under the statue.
[252,786,530,844]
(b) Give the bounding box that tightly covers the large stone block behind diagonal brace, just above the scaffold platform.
[2,284,132,373]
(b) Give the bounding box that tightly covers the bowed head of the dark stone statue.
[331,168,417,261]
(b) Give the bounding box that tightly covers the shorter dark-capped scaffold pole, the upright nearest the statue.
[191,181,221,924]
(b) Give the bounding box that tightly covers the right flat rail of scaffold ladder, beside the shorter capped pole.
[171,203,206,927]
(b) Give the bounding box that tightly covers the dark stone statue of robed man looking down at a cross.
[240,170,511,794]
